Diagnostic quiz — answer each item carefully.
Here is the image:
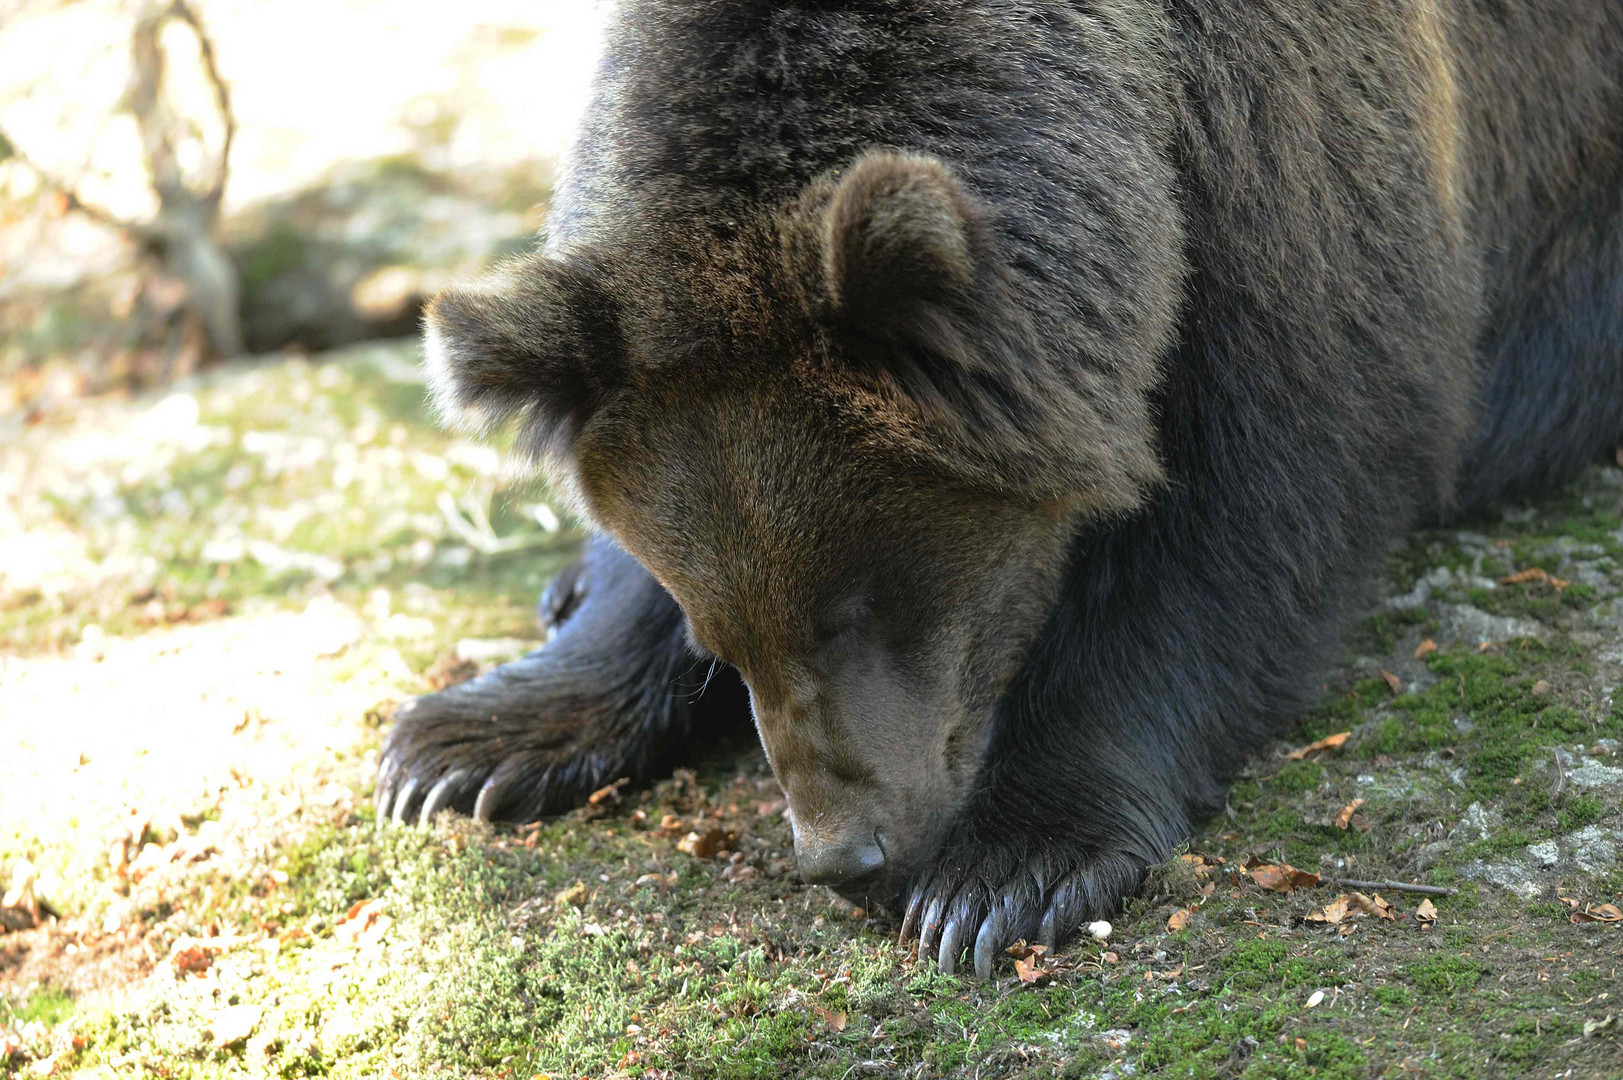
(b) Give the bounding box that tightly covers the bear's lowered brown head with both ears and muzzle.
[425,151,1160,900]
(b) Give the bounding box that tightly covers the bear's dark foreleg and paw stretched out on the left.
[377,538,748,822]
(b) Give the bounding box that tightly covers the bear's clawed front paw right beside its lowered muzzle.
[901,843,1146,979]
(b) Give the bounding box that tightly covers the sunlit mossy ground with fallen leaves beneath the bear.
[0,346,1623,1080]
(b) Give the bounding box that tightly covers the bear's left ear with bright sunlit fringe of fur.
[424,255,620,456]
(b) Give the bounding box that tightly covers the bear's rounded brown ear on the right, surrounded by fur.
[823,151,980,338]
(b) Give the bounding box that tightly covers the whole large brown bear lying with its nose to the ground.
[378,0,1623,976]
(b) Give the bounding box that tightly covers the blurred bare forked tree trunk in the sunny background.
[0,0,242,356]
